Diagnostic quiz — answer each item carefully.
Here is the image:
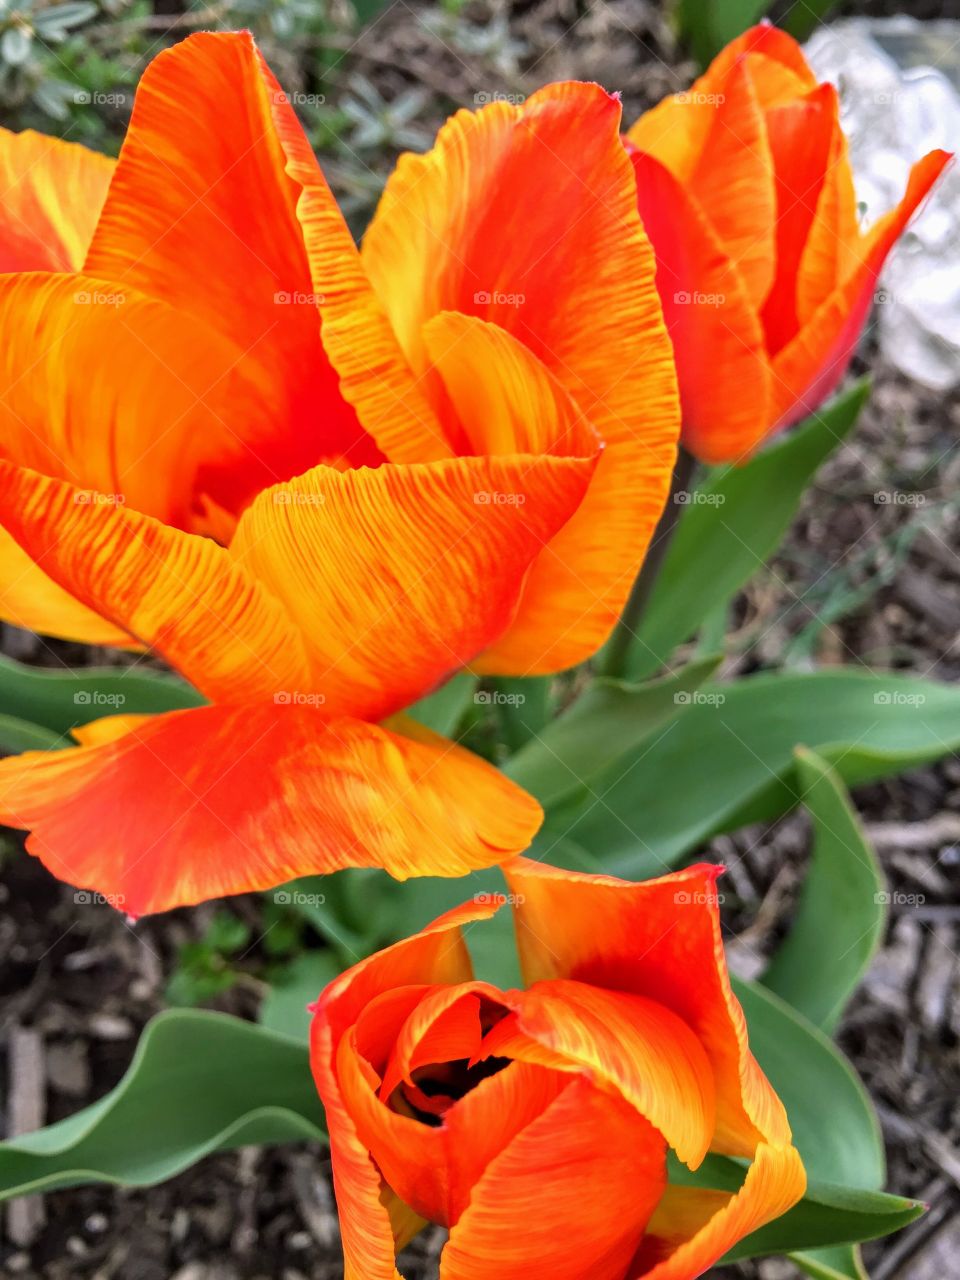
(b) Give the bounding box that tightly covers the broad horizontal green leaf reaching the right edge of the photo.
[544,669,960,878]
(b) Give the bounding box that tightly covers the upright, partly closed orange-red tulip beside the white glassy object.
[627,24,950,463]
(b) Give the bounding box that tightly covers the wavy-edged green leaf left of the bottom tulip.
[0,1010,324,1199]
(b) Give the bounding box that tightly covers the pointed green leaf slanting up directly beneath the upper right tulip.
[627,383,869,680]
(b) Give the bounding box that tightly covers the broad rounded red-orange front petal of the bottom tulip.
[440,1076,666,1280]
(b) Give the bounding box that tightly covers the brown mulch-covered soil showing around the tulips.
[0,0,960,1280]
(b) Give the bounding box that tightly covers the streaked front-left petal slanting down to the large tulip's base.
[0,461,307,703]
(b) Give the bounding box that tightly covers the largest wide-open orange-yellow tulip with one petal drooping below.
[0,35,680,914]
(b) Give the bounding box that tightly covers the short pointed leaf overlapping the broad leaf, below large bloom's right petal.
[504,655,721,805]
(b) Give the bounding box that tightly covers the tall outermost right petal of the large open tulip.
[362,83,678,673]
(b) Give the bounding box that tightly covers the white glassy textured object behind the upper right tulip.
[806,15,960,390]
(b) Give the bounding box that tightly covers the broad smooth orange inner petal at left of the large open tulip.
[0,273,273,526]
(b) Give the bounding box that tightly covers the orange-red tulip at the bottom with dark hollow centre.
[311,859,806,1280]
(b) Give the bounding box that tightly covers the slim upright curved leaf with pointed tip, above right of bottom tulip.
[763,750,887,1033]
